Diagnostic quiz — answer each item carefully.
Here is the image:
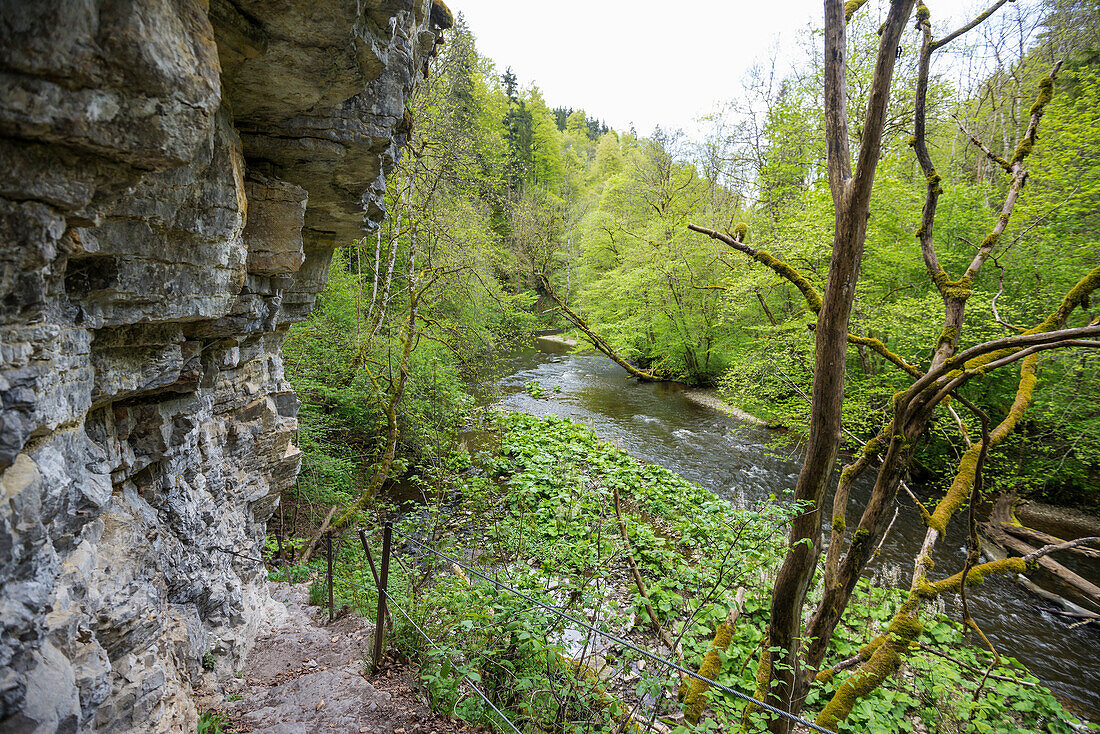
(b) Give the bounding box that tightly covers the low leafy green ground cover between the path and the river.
[283,414,1080,733]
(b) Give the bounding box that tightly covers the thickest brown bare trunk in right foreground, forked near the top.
[766,0,915,734]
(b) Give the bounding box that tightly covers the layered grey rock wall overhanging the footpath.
[0,0,451,733]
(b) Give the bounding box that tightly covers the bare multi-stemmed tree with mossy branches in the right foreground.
[692,0,1100,732]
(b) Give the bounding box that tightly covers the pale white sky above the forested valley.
[448,0,822,135]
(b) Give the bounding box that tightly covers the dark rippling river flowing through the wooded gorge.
[473,339,1100,721]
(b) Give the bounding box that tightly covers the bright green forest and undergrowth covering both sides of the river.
[268,0,1100,734]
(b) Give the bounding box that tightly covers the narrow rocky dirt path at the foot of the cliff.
[207,583,475,734]
